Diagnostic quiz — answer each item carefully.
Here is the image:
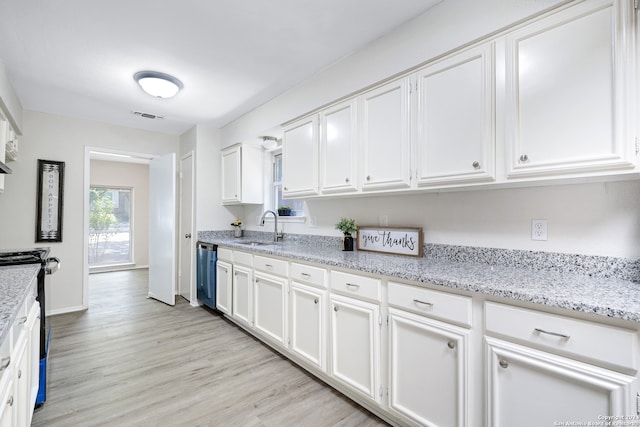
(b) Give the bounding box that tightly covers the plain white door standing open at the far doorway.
[149,153,176,305]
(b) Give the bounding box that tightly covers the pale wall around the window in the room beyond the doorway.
[91,160,149,267]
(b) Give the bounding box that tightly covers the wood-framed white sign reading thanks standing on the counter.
[358,227,422,257]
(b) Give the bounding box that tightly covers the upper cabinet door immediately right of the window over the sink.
[282,115,318,198]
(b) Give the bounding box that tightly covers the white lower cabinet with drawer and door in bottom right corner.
[485,302,638,427]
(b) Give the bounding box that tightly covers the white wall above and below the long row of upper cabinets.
[221,0,640,258]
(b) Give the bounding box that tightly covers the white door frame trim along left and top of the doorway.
[82,145,159,310]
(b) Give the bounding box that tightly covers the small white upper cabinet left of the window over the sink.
[221,144,264,205]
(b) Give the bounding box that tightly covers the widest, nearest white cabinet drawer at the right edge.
[485,302,638,371]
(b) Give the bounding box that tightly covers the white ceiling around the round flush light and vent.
[0,0,440,134]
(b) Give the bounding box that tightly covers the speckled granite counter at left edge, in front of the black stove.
[0,264,40,343]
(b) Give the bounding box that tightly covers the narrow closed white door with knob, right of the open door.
[178,154,195,302]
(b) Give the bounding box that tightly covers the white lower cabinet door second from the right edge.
[389,308,469,427]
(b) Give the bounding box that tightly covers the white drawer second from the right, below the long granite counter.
[389,282,471,327]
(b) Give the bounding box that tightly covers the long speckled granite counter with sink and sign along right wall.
[198,232,640,322]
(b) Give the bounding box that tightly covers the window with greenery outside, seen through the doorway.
[89,186,133,267]
